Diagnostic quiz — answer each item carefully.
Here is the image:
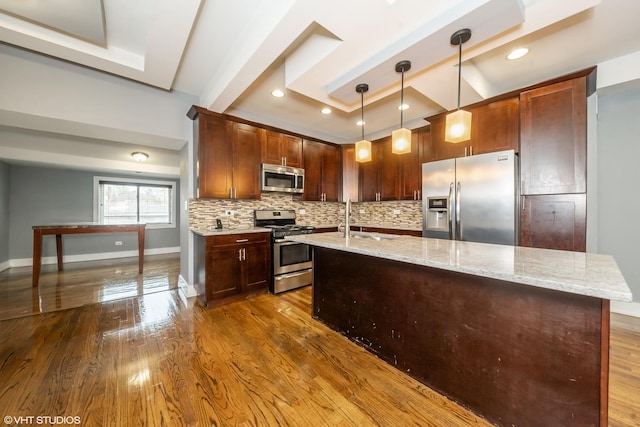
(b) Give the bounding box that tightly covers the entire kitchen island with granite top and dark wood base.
[290,233,632,426]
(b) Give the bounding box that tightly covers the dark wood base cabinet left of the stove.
[196,232,271,305]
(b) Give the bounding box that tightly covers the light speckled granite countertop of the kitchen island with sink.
[287,232,632,302]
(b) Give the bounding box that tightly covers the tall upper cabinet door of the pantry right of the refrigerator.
[520,77,587,195]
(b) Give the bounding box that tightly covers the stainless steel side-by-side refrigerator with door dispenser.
[422,150,519,245]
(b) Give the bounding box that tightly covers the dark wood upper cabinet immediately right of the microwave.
[303,139,342,202]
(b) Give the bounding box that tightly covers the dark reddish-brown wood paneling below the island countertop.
[313,247,609,426]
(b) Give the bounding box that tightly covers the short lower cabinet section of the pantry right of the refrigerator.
[520,193,587,252]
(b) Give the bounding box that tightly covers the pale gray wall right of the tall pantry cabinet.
[597,85,640,302]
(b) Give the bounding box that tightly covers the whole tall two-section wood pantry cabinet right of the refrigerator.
[520,69,595,252]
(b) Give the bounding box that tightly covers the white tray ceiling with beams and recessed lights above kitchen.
[0,0,640,176]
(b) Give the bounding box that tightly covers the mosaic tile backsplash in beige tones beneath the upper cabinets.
[189,193,422,229]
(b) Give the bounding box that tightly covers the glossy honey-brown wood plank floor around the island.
[0,259,640,427]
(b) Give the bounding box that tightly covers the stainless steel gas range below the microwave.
[254,210,315,294]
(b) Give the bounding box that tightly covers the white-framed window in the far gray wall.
[94,176,176,228]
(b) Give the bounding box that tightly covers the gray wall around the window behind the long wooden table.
[8,165,181,260]
